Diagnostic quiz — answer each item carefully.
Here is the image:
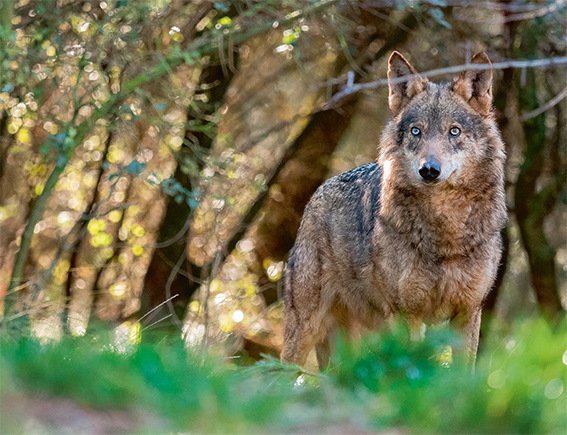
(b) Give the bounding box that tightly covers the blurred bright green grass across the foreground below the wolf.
[0,320,567,434]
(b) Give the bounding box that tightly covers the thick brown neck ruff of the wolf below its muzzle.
[378,137,506,262]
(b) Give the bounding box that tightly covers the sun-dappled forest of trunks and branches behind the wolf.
[0,0,567,431]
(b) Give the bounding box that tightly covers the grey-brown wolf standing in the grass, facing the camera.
[282,52,506,368]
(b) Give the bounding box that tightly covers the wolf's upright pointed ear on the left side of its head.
[388,51,427,115]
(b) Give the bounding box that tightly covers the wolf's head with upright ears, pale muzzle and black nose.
[380,52,504,188]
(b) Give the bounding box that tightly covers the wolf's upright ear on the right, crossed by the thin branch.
[453,51,492,116]
